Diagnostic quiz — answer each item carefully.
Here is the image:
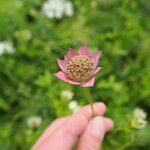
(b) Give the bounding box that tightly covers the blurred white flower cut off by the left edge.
[0,41,14,55]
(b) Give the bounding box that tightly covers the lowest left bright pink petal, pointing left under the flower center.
[54,71,81,85]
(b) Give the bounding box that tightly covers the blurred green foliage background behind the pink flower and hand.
[0,0,150,150]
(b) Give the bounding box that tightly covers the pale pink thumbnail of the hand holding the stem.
[91,117,106,139]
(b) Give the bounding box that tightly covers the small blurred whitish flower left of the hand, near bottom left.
[27,116,42,128]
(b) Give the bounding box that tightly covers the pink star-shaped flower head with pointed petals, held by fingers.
[55,45,101,87]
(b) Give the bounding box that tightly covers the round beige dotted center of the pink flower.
[66,55,93,82]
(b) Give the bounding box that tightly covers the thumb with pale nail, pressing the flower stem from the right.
[77,117,113,150]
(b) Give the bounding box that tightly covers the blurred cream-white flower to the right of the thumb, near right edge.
[131,108,147,129]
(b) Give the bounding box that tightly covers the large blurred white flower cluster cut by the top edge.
[42,0,73,19]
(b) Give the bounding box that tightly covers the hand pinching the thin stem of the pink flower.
[31,102,113,150]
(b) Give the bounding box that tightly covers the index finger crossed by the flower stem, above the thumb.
[36,103,106,150]
